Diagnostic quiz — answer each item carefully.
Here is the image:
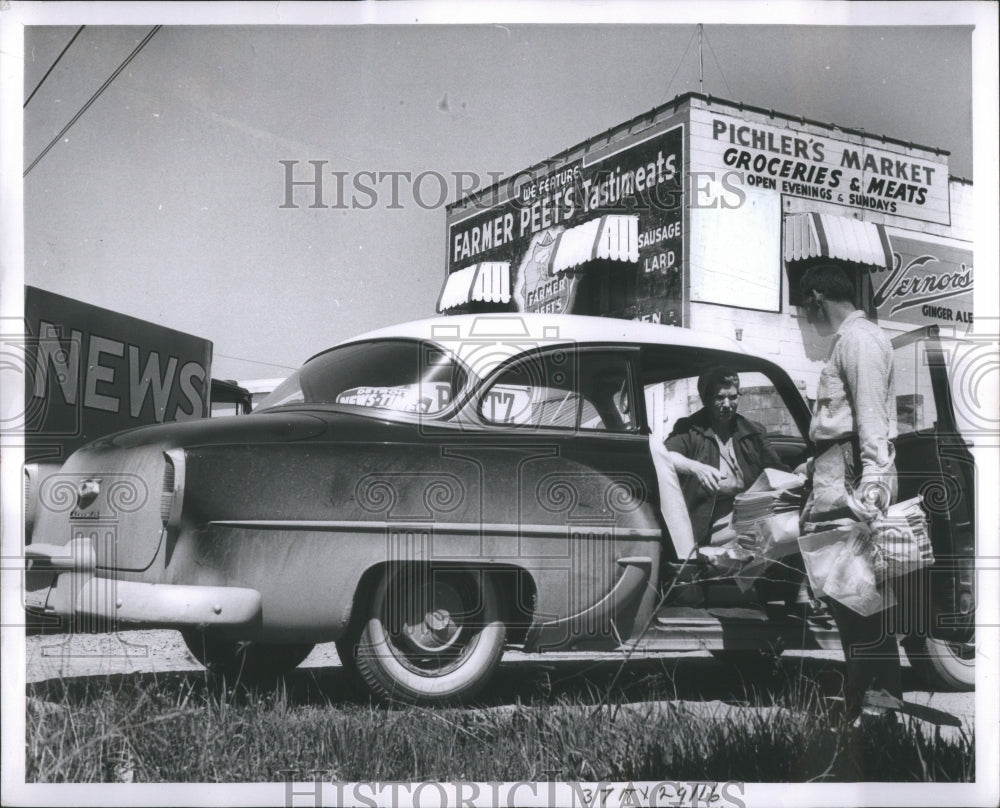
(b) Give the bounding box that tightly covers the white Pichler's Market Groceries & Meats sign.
[692,110,951,224]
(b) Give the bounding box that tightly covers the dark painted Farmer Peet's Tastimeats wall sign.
[448,125,684,324]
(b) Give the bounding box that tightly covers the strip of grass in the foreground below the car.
[26,660,975,782]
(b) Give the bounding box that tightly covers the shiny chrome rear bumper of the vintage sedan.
[25,539,261,628]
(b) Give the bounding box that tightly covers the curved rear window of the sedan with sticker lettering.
[252,340,468,415]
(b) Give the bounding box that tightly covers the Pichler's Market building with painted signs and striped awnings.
[438,93,973,432]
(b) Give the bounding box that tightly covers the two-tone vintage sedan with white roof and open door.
[26,315,974,704]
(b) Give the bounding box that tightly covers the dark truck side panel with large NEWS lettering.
[24,286,212,460]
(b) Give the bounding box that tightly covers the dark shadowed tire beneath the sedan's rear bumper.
[181,629,313,684]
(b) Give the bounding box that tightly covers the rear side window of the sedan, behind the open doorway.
[479,350,637,432]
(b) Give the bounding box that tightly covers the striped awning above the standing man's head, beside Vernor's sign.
[785,213,892,269]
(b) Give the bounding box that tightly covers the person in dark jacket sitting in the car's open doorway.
[665,367,789,545]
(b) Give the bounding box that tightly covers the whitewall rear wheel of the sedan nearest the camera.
[354,566,506,704]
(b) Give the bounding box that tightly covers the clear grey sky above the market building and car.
[3,3,996,380]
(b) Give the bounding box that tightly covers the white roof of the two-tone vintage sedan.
[313,313,746,378]
